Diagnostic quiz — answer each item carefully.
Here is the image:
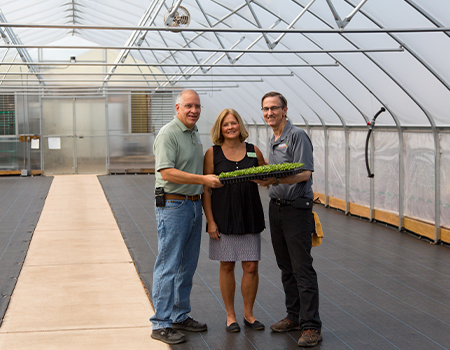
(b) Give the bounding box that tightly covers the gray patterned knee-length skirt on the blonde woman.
[209,233,261,261]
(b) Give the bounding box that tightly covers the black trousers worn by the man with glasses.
[269,201,322,330]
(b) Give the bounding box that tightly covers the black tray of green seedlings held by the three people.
[218,163,303,185]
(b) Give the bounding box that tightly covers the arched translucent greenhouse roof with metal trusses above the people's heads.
[0,0,450,129]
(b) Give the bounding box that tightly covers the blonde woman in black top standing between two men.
[203,108,265,333]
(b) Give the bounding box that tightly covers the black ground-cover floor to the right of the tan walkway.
[100,175,450,350]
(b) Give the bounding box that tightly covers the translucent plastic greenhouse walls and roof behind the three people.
[0,0,450,243]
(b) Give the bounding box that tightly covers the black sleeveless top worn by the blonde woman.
[211,143,265,235]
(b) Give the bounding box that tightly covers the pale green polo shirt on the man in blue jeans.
[153,116,203,196]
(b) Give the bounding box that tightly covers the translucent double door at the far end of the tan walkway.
[41,98,107,175]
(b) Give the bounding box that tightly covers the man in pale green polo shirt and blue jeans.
[150,90,222,344]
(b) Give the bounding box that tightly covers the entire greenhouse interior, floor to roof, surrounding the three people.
[0,0,450,350]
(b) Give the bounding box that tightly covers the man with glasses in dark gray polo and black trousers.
[257,92,322,347]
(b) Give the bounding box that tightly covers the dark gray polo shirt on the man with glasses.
[269,121,314,200]
